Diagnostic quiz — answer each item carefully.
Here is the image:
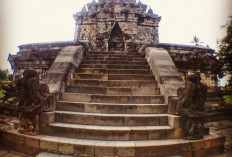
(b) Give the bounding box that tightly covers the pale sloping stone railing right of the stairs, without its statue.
[144,46,184,115]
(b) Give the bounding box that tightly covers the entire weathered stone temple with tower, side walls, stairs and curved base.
[0,0,225,157]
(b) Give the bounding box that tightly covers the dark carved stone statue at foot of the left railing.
[16,70,53,135]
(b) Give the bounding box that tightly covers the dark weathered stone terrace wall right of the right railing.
[157,43,223,88]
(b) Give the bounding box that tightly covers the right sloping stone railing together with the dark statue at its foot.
[144,47,207,140]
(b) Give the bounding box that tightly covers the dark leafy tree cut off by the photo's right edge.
[217,16,232,86]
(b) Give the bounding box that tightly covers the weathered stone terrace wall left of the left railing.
[8,41,78,80]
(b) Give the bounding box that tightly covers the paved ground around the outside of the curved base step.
[0,116,232,157]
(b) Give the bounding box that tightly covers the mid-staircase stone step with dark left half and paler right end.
[65,86,160,96]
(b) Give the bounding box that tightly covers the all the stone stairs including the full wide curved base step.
[0,49,225,157]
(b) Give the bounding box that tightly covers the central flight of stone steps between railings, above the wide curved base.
[39,51,188,156]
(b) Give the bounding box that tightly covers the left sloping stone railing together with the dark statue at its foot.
[17,43,89,135]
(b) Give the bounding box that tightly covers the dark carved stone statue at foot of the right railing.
[176,73,207,140]
